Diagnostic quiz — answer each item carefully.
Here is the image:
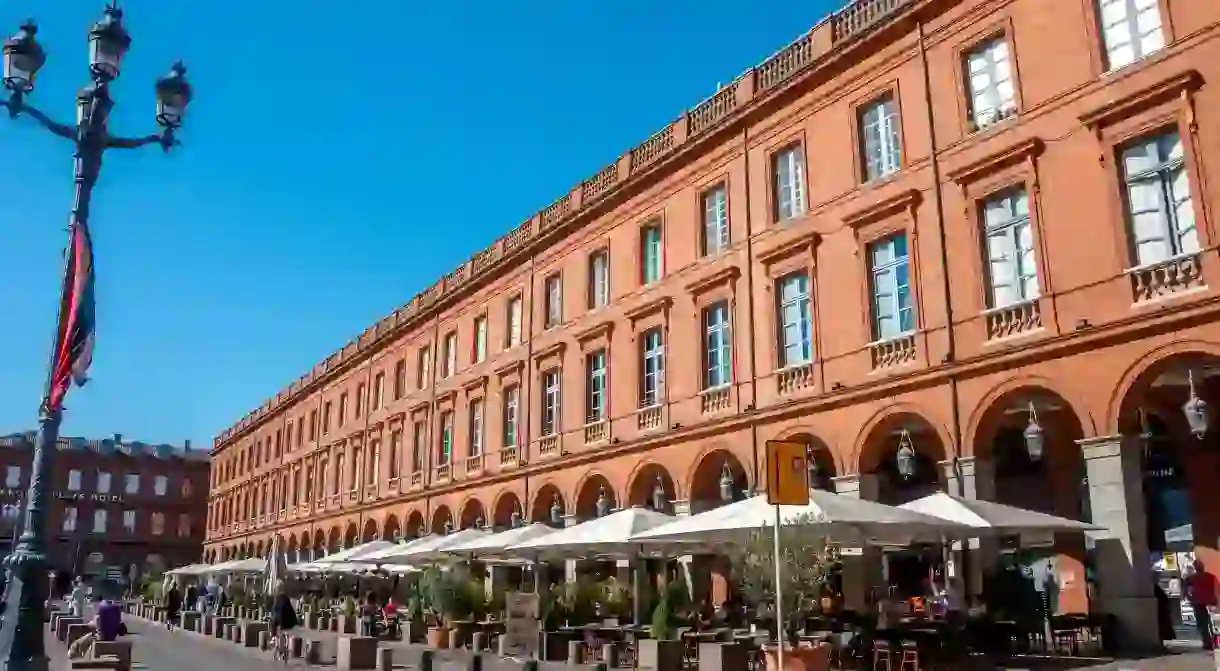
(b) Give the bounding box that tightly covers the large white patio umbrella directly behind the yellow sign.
[632,489,969,544]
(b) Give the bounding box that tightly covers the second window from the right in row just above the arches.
[983,187,1038,307]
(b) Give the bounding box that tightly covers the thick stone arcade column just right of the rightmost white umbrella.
[1077,436,1161,650]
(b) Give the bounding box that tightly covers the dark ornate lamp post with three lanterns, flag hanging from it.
[0,2,192,671]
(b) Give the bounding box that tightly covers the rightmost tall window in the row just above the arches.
[1122,131,1199,266]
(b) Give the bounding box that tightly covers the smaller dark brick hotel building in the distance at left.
[0,432,210,582]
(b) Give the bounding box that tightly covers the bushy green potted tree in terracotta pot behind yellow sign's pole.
[733,516,838,671]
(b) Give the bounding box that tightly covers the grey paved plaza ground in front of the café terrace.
[49,607,1216,671]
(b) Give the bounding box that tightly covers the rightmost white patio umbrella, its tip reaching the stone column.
[899,492,1103,536]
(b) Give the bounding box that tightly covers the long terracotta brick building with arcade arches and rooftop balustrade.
[205,0,1220,649]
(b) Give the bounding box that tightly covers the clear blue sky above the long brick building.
[0,0,843,445]
